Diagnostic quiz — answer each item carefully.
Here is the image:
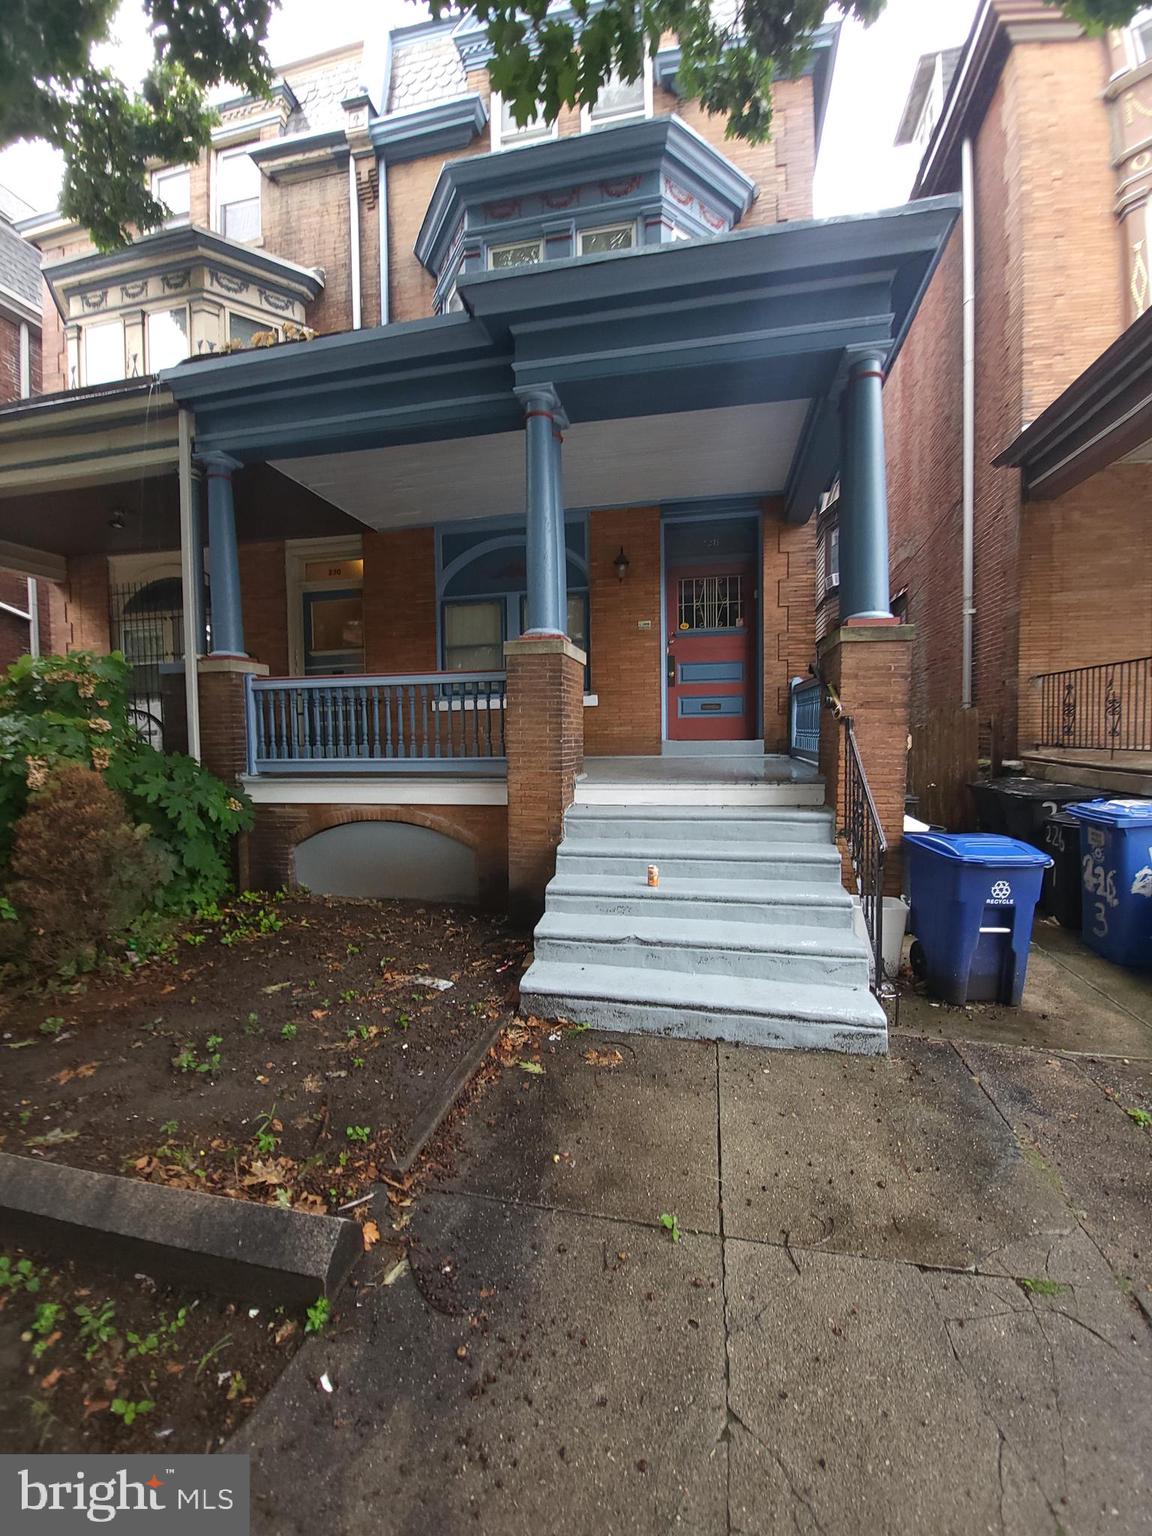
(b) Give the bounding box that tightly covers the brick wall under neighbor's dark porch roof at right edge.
[1020,464,1152,748]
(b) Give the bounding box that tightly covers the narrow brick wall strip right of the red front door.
[760,502,816,753]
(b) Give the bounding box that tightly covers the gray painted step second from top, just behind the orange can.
[556,837,840,885]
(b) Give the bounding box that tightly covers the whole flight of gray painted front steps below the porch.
[521,803,888,1054]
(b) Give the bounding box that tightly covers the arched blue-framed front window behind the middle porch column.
[438,516,588,671]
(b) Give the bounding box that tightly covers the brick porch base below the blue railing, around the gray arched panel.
[249,803,508,906]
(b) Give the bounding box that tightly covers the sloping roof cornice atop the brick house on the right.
[912,0,1084,197]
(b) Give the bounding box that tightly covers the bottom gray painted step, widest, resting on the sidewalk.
[521,960,888,1055]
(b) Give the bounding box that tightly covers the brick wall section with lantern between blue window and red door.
[584,507,664,756]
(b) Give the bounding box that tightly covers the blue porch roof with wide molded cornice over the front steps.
[163,197,958,525]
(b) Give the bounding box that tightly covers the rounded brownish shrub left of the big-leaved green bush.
[8,763,172,974]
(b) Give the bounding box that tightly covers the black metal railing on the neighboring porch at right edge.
[1032,656,1152,753]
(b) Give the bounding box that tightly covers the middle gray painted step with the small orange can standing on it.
[545,871,852,931]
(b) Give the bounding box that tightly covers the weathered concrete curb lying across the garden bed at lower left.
[0,1152,364,1306]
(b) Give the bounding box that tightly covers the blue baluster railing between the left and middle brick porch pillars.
[247,673,505,774]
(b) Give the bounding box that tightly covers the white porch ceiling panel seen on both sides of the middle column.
[275,399,808,528]
